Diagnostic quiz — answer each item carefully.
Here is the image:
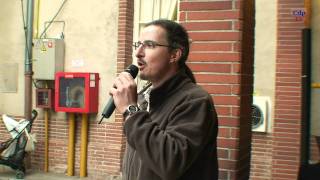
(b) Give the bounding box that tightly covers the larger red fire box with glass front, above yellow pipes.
[55,72,99,113]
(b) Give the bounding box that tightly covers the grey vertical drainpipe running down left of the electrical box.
[24,0,34,120]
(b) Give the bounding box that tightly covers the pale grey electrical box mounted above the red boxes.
[32,39,64,80]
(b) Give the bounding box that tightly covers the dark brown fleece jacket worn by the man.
[123,71,218,180]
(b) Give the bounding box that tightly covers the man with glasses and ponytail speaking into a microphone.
[110,19,218,180]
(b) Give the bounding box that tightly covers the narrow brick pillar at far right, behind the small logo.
[272,0,304,180]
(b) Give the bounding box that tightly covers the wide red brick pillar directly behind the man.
[179,0,254,179]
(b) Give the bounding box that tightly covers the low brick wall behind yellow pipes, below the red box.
[30,115,124,179]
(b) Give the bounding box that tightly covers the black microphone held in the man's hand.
[99,64,139,124]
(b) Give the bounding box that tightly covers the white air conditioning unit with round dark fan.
[252,96,271,132]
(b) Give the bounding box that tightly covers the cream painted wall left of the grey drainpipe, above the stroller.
[0,1,25,115]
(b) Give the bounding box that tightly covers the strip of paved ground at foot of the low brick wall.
[0,171,88,180]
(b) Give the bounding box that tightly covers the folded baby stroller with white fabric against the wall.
[0,110,38,179]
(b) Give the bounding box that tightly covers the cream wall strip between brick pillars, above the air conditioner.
[254,0,277,132]
